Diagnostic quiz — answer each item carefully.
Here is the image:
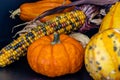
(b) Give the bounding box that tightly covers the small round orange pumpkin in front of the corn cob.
[27,34,84,77]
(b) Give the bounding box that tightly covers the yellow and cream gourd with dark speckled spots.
[85,29,120,80]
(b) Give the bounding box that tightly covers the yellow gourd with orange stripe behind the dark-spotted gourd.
[99,2,120,31]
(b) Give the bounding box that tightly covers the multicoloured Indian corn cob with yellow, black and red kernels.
[0,10,86,67]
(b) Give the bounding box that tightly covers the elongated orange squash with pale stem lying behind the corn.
[10,0,73,21]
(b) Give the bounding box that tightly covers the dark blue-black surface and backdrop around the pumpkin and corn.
[0,0,96,80]
